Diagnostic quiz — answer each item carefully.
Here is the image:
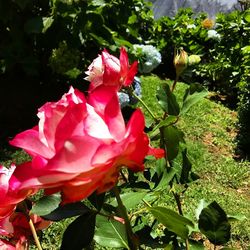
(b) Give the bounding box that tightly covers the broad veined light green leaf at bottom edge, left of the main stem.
[94,215,129,249]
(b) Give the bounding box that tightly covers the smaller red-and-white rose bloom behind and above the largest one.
[85,47,138,91]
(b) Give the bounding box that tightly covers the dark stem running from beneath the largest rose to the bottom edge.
[113,186,138,250]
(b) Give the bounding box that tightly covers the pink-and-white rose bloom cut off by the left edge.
[0,164,36,219]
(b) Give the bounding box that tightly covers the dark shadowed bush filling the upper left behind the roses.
[0,0,153,141]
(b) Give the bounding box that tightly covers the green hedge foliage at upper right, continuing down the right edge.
[151,8,250,156]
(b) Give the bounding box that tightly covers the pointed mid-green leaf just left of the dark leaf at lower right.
[148,207,194,239]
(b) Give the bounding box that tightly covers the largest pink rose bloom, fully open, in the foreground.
[10,85,164,203]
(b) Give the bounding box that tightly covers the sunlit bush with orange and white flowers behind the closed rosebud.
[150,9,250,104]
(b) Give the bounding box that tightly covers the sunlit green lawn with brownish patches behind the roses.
[0,76,250,250]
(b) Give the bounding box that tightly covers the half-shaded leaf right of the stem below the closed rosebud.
[180,83,208,114]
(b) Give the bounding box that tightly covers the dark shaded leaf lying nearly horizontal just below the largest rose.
[42,202,90,221]
